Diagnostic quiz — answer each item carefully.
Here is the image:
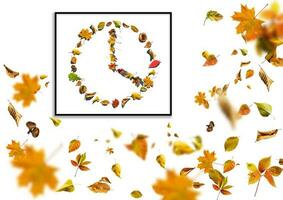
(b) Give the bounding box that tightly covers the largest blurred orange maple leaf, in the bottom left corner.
[12,146,57,196]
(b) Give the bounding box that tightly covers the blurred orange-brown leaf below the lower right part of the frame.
[126,134,147,160]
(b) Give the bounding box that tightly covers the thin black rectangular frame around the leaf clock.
[54,12,172,117]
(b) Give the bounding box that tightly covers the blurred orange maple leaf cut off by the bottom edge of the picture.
[152,171,198,200]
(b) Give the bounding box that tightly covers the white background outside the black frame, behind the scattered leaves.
[0,0,283,200]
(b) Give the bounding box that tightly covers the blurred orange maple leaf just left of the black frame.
[13,74,40,107]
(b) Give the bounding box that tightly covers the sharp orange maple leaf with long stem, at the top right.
[232,5,263,41]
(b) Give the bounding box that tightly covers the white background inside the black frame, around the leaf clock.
[57,14,170,114]
